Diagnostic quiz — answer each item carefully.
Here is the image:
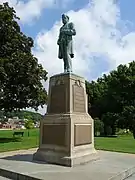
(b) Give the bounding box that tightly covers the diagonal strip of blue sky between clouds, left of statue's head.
[21,0,89,38]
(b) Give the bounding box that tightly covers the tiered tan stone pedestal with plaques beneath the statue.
[33,73,97,167]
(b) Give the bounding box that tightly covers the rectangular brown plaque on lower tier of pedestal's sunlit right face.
[74,124,92,146]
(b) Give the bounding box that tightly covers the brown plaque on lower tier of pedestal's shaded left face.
[42,124,67,146]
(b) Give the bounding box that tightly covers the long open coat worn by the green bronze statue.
[57,22,76,59]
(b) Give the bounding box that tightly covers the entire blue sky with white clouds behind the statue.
[0,0,135,114]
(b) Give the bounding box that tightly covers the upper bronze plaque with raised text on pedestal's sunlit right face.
[73,85,85,112]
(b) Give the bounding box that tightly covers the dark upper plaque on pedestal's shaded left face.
[49,84,66,113]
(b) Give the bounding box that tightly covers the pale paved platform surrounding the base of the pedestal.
[0,149,135,180]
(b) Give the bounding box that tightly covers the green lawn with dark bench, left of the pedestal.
[0,129,39,152]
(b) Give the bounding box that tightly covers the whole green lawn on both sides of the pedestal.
[0,129,135,154]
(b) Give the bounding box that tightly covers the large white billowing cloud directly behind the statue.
[34,0,135,114]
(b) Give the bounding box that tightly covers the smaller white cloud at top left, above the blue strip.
[0,0,73,23]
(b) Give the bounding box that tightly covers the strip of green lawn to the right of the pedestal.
[95,135,135,154]
